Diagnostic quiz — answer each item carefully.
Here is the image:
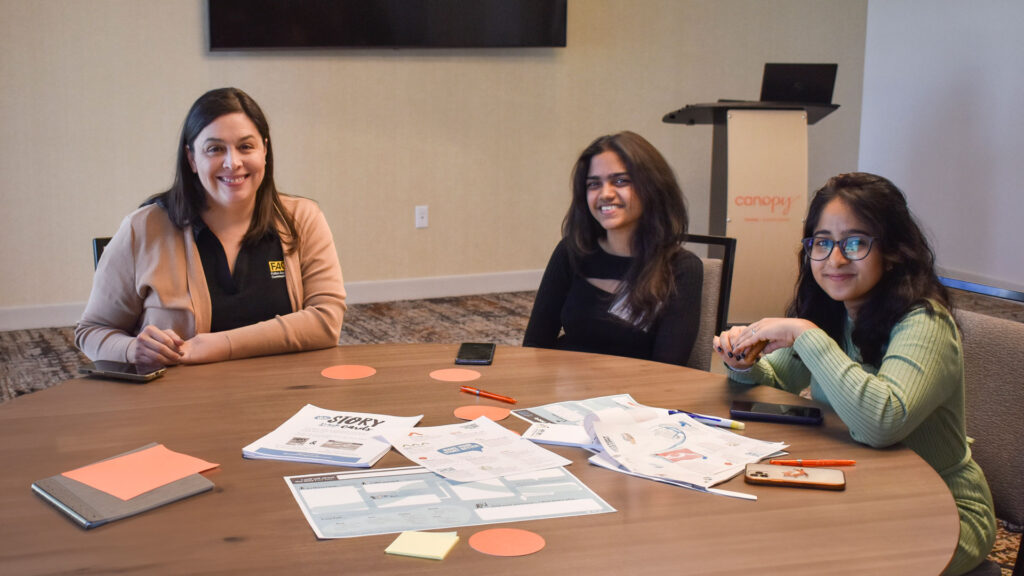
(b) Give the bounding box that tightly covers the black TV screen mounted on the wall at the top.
[207,0,567,50]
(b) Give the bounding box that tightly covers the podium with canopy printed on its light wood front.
[663,100,839,324]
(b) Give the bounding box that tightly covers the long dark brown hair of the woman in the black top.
[562,132,689,328]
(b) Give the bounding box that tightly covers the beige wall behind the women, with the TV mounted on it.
[0,0,866,325]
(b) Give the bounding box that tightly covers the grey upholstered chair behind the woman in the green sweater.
[956,311,1024,576]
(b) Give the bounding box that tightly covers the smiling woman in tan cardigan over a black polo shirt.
[75,88,345,365]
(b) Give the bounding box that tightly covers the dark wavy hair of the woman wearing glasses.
[786,172,952,366]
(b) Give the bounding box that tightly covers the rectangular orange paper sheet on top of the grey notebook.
[62,444,220,500]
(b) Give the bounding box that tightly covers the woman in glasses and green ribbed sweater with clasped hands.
[714,173,995,574]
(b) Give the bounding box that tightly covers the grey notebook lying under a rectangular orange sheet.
[32,444,213,528]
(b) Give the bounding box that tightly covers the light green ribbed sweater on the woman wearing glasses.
[729,305,995,574]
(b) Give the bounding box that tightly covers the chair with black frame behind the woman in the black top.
[686,234,736,371]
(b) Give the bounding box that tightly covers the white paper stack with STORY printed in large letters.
[242,404,423,468]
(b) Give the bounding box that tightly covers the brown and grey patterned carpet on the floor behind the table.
[0,292,1024,576]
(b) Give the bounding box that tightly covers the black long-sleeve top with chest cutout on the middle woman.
[522,240,703,365]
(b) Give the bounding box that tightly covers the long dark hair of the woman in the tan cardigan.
[146,88,299,252]
